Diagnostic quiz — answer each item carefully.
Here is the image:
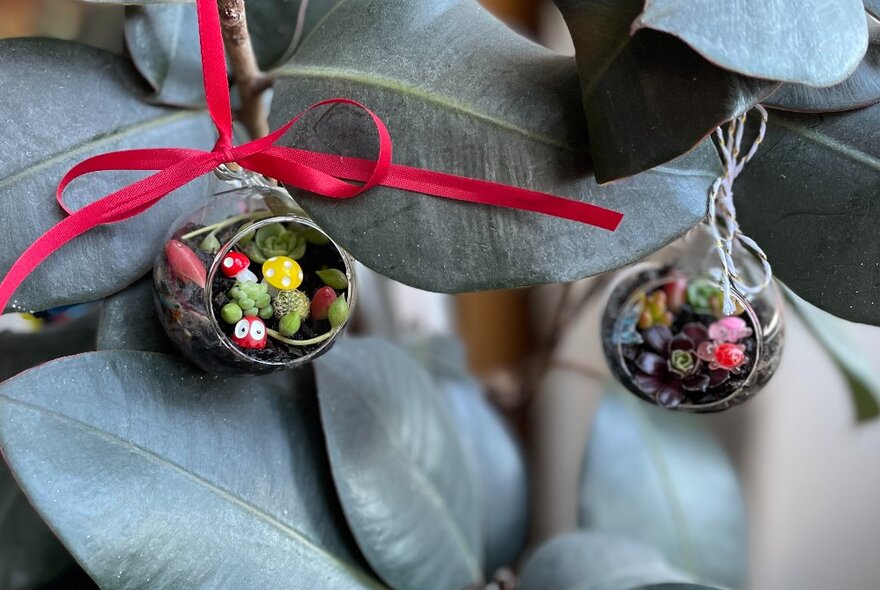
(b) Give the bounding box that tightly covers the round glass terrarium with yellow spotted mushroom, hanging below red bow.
[153,166,356,375]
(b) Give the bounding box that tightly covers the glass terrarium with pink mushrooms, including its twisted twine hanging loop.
[602,107,784,412]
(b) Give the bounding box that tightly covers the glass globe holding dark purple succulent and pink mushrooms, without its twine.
[603,267,782,411]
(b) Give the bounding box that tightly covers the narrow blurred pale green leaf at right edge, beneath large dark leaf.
[785,289,880,422]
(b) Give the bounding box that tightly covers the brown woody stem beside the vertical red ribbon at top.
[217,0,269,139]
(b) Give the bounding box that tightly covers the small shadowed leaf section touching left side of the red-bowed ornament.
[98,274,177,355]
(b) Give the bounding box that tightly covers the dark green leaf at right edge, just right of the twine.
[735,105,880,324]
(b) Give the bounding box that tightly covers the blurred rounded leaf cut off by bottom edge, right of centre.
[519,531,688,590]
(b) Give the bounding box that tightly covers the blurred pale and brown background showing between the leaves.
[0,0,880,590]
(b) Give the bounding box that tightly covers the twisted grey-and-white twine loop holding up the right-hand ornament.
[706,105,773,315]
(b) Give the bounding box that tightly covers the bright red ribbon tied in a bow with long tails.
[0,0,623,311]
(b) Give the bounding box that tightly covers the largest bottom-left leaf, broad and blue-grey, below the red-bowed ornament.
[0,351,377,590]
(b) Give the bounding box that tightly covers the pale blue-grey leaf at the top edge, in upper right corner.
[633,0,868,86]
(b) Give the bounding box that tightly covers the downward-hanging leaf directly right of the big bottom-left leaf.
[315,339,482,590]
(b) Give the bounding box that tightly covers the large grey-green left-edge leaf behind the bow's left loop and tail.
[0,39,214,310]
